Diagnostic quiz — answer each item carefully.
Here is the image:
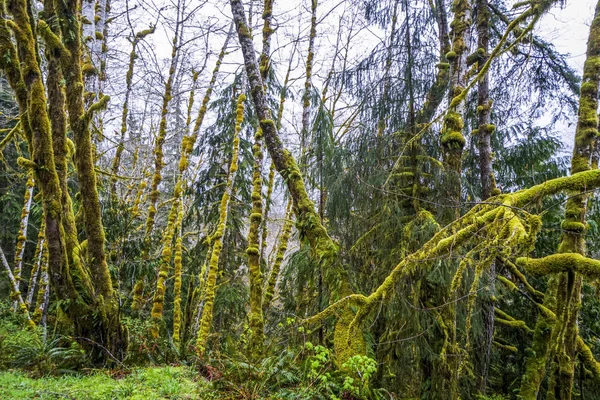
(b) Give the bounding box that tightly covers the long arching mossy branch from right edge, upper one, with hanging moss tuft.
[305,170,600,358]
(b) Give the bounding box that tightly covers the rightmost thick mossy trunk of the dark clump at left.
[45,0,126,357]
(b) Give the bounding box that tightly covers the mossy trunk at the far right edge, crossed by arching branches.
[520,2,600,400]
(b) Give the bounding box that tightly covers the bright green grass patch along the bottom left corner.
[0,366,214,400]
